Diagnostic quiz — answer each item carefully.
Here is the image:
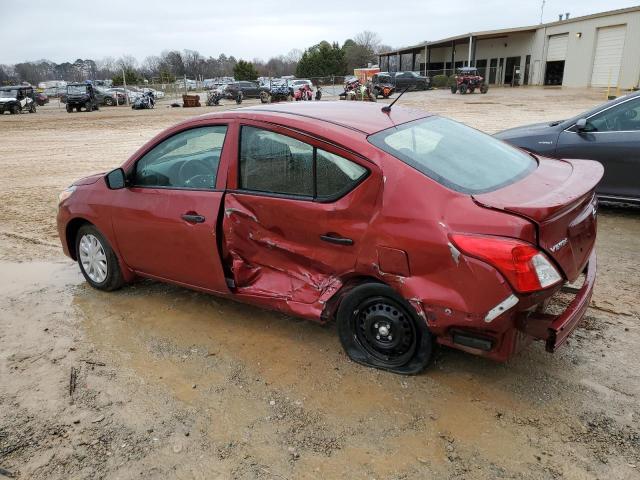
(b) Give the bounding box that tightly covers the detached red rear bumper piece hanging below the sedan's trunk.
[517,250,597,352]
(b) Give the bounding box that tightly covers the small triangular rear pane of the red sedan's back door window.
[316,149,367,199]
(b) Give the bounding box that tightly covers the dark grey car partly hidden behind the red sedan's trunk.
[496,92,640,204]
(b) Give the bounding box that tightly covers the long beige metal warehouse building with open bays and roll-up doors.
[379,6,640,88]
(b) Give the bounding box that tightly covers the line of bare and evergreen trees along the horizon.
[0,31,390,85]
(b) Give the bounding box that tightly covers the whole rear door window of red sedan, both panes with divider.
[240,126,368,201]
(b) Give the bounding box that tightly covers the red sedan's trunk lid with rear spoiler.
[473,157,604,281]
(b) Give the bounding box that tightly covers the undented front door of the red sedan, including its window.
[112,123,233,293]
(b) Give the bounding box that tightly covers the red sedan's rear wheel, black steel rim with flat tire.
[336,283,433,375]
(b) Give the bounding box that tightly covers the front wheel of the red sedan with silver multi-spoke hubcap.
[76,225,124,292]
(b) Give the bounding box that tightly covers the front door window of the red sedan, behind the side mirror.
[134,125,227,190]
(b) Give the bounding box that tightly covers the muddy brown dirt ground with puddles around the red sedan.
[0,88,640,480]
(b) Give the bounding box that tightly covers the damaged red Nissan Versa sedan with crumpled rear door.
[58,102,603,374]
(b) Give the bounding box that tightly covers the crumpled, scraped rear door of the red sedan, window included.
[222,121,381,316]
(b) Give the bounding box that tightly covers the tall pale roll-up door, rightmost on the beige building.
[591,25,627,87]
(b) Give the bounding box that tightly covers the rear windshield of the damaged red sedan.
[369,116,538,194]
